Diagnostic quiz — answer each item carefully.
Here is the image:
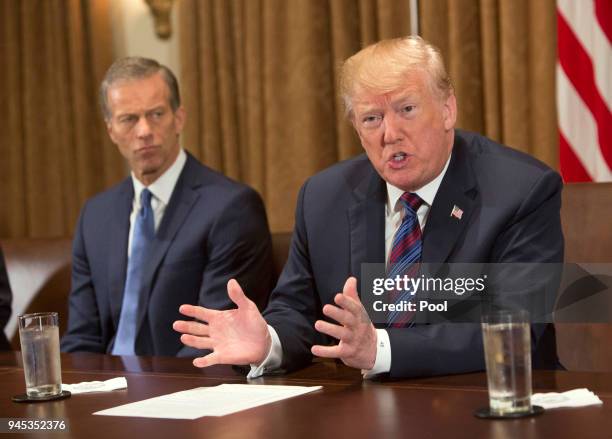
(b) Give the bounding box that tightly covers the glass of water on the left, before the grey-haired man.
[19,312,62,399]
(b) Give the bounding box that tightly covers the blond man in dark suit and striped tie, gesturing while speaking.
[174,37,563,378]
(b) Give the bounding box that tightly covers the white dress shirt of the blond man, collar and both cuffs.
[247,156,450,378]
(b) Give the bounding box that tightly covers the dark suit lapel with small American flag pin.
[422,134,477,263]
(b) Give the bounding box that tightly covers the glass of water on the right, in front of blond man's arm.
[482,310,532,416]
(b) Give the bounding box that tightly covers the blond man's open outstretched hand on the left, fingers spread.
[172,279,272,367]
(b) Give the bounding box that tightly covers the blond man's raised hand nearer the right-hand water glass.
[312,277,377,370]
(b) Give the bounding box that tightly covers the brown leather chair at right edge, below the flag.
[555,183,612,372]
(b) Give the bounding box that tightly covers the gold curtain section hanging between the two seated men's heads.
[179,0,410,231]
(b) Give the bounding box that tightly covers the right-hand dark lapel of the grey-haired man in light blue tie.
[136,154,201,333]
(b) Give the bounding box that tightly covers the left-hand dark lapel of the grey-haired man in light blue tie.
[107,178,134,328]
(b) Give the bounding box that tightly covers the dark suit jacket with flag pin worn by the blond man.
[265,130,563,377]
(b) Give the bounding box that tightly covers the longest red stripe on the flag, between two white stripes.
[557,12,612,168]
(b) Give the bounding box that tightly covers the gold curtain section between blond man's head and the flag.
[419,0,558,168]
